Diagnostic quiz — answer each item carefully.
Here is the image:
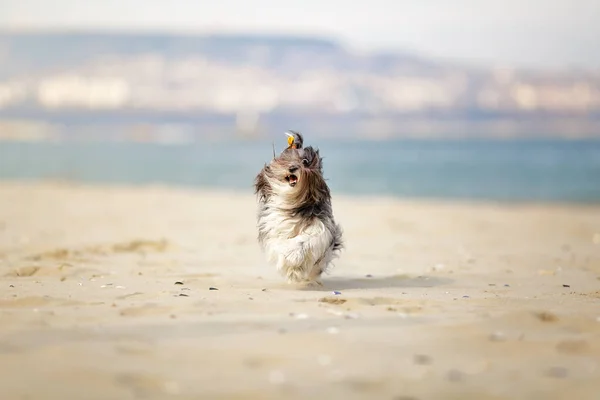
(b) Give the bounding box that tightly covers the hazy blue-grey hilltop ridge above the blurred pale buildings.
[0,32,433,72]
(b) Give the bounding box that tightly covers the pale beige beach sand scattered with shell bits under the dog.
[0,182,600,400]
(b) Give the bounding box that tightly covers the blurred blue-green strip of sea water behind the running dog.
[0,138,600,203]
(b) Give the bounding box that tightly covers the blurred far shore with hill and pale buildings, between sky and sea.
[0,31,600,137]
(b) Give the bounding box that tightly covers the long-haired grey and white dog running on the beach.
[254,132,344,285]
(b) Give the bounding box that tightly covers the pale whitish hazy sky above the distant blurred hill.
[0,0,600,68]
